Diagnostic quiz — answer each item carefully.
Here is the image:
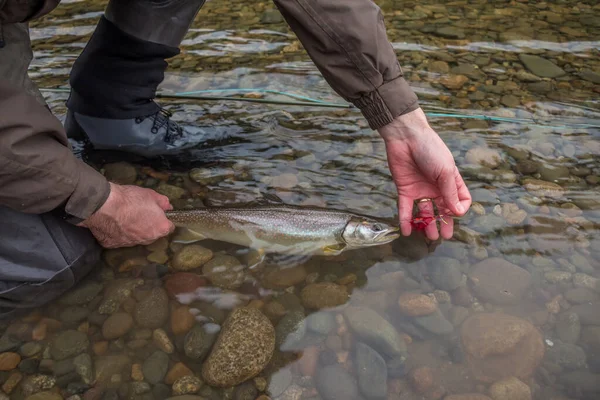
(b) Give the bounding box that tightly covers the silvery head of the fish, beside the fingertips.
[342,217,400,248]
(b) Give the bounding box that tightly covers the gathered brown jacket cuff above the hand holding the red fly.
[352,77,419,129]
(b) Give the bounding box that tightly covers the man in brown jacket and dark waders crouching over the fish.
[0,0,471,318]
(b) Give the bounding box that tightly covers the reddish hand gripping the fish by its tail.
[79,183,175,248]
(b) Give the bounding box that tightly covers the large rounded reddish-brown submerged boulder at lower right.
[461,313,544,382]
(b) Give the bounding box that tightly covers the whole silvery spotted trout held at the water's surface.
[166,204,400,255]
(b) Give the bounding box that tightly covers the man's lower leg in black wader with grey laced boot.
[65,0,211,157]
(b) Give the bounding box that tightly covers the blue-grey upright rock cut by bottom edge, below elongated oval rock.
[355,342,387,399]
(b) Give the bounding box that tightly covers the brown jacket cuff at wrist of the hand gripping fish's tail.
[65,159,110,219]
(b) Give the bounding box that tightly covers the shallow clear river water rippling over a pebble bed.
[0,0,600,400]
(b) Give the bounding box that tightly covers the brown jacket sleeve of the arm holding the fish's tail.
[0,79,110,219]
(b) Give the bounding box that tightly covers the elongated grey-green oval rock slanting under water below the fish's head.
[343,306,406,358]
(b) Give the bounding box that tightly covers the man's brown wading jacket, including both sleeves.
[0,0,418,219]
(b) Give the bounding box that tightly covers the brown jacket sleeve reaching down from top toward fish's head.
[273,0,419,129]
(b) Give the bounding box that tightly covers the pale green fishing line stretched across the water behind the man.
[40,88,600,129]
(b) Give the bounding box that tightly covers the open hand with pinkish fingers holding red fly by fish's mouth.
[378,108,471,240]
